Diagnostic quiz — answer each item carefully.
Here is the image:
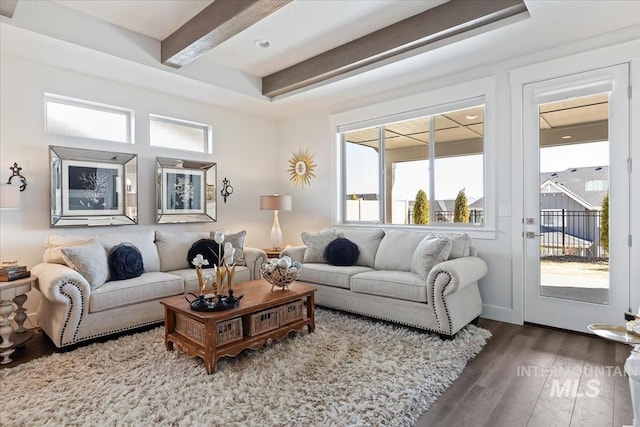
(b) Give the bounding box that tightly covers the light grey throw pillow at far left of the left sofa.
[61,240,109,289]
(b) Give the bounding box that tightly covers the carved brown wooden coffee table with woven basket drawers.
[160,279,316,374]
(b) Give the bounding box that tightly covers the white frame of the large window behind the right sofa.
[330,76,497,239]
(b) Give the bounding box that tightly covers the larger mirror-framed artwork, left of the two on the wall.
[49,146,138,228]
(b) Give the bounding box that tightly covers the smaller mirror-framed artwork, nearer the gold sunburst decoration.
[156,157,217,224]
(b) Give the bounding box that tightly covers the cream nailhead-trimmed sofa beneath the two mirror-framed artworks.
[32,231,267,347]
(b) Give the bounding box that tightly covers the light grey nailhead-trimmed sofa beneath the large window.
[281,227,487,338]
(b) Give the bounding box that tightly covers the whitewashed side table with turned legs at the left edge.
[0,276,38,365]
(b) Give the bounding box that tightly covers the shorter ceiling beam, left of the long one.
[160,0,291,68]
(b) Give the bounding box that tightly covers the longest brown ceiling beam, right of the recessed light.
[262,0,527,97]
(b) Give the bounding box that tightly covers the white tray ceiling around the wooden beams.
[0,0,640,117]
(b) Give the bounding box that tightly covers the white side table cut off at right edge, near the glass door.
[589,324,640,427]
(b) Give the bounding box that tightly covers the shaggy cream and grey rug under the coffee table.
[0,309,491,427]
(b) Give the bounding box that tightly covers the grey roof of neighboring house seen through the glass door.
[540,166,609,209]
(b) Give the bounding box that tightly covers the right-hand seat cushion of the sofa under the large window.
[351,270,427,305]
